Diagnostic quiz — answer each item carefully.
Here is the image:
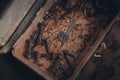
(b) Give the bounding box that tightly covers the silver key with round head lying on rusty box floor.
[57,20,76,43]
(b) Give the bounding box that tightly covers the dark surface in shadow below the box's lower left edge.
[0,52,45,80]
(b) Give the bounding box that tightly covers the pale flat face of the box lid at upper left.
[0,0,35,46]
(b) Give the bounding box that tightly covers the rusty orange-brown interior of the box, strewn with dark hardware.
[13,0,116,80]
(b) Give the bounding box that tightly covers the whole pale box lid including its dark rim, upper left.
[0,0,46,53]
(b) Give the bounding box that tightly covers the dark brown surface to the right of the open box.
[77,20,120,80]
